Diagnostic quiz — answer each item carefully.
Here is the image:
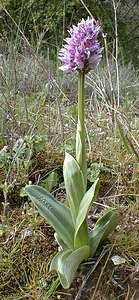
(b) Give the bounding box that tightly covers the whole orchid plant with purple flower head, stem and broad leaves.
[25,18,118,288]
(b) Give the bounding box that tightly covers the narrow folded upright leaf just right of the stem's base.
[74,179,99,248]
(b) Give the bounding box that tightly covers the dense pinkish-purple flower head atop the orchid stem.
[59,17,103,75]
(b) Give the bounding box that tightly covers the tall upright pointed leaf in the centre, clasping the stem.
[63,153,85,224]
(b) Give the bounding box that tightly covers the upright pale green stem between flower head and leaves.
[76,71,87,188]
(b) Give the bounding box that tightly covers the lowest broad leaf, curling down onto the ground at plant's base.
[50,246,90,289]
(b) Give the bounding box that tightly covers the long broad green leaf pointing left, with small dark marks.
[25,185,74,249]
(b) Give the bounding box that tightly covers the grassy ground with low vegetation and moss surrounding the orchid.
[0,1,139,300]
